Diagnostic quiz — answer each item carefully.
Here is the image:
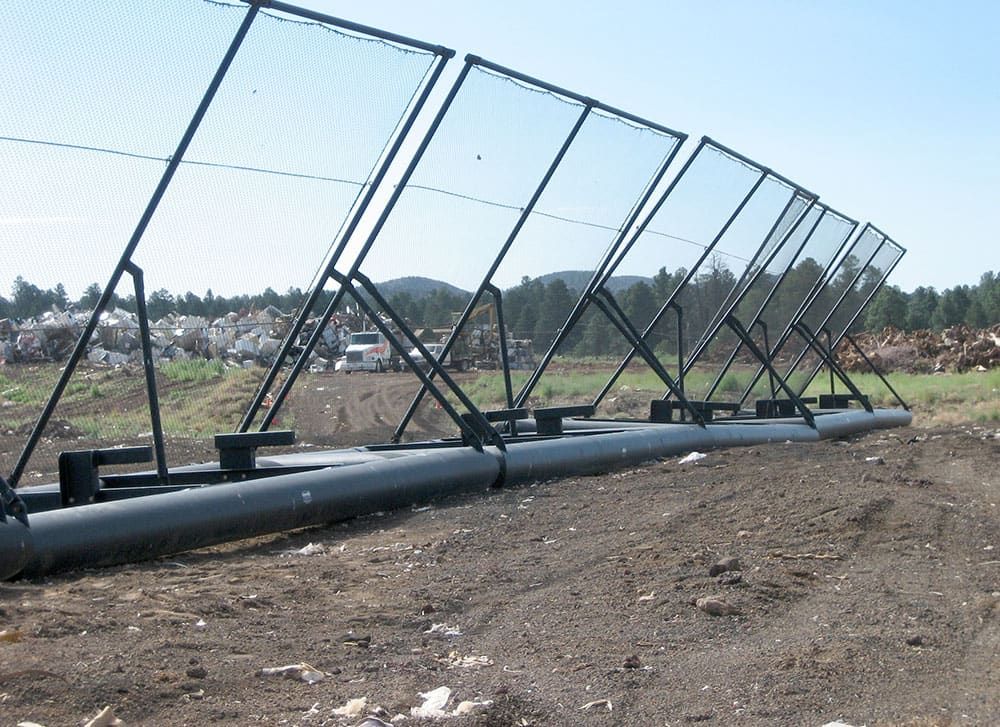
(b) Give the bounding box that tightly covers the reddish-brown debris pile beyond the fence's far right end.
[837,324,1000,373]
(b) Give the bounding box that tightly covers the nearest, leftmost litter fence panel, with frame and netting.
[0,0,451,482]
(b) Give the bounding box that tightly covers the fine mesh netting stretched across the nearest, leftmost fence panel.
[0,0,436,484]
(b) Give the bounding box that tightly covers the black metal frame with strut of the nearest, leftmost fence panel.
[9,0,454,487]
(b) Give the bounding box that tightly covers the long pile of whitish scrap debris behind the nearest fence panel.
[0,306,352,366]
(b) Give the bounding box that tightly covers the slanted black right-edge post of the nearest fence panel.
[236,51,454,432]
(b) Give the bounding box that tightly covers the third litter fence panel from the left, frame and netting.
[515,138,814,416]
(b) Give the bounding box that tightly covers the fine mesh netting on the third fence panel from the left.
[532,145,809,413]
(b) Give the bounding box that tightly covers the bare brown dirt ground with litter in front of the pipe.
[0,372,1000,727]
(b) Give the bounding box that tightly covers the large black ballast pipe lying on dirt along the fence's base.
[0,410,911,578]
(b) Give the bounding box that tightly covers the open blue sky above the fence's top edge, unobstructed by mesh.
[301,0,1000,290]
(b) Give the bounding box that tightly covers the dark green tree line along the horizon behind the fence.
[0,266,1000,356]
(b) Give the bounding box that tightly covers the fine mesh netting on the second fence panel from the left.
[336,66,678,435]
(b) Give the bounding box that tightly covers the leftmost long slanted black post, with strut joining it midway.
[10,5,258,487]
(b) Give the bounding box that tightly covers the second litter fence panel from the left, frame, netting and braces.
[249,56,683,439]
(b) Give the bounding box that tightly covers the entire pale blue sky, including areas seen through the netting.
[0,0,1000,296]
